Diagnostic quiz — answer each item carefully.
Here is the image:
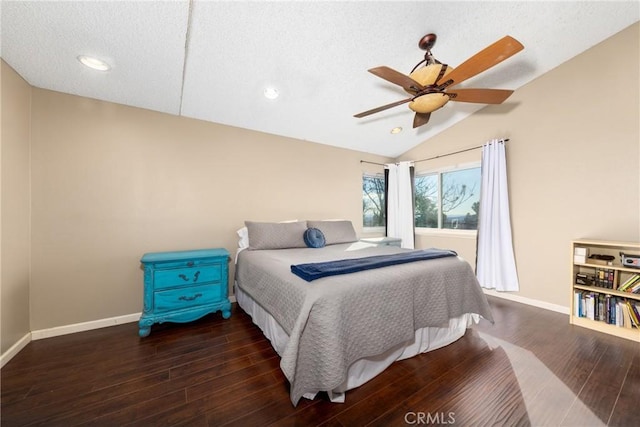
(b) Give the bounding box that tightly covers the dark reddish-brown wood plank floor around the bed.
[1,298,640,426]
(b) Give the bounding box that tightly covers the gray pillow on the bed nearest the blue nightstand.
[244,221,307,249]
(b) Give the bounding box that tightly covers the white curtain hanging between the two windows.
[385,162,414,249]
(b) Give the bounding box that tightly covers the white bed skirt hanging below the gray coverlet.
[234,285,480,403]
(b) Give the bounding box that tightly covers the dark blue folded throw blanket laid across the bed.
[291,249,458,282]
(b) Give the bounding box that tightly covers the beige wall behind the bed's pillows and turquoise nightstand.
[31,89,389,330]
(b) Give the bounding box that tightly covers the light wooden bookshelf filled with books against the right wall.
[569,239,640,342]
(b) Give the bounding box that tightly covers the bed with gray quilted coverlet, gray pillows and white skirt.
[235,221,493,405]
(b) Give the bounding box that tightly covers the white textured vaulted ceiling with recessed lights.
[0,0,640,157]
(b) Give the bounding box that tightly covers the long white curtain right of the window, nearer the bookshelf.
[476,140,520,291]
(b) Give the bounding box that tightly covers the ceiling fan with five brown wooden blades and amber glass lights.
[354,34,524,128]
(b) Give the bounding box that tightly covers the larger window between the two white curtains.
[414,166,481,230]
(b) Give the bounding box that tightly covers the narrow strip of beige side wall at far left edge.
[0,61,31,354]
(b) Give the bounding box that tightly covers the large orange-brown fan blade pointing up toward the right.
[438,36,524,89]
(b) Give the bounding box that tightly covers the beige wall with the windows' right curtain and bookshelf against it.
[402,24,640,307]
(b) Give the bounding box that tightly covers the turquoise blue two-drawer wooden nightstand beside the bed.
[138,248,231,337]
